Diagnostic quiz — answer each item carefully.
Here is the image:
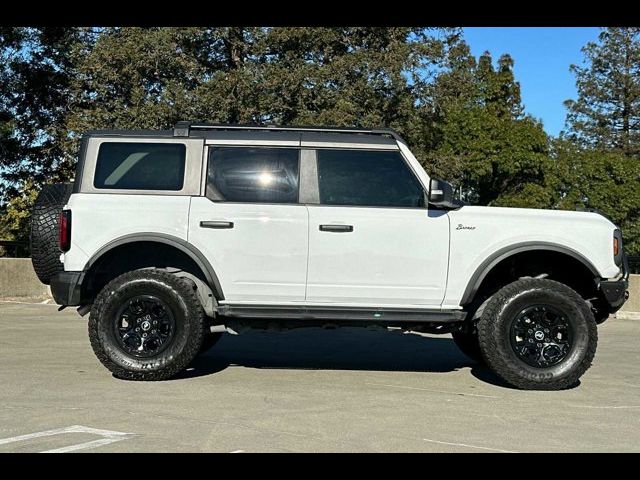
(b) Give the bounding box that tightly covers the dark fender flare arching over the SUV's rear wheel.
[83,232,224,300]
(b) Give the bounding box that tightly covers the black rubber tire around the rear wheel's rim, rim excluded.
[89,269,206,380]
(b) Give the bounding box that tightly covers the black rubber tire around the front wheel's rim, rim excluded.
[477,278,598,390]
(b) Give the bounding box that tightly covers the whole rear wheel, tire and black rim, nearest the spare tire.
[89,269,205,380]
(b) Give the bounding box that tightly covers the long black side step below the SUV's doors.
[217,305,466,323]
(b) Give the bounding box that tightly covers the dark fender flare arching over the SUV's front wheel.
[460,242,600,306]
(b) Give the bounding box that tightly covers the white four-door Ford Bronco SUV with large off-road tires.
[31,122,628,389]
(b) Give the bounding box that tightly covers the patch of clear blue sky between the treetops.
[464,27,600,135]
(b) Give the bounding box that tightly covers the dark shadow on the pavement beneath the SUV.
[175,328,511,388]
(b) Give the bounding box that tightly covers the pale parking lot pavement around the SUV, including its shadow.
[0,303,640,453]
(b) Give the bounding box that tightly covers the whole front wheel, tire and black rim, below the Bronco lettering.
[478,278,598,390]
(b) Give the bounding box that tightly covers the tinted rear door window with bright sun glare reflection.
[207,147,300,203]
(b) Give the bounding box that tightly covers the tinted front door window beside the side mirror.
[317,150,425,207]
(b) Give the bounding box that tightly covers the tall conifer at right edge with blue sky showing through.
[565,28,640,157]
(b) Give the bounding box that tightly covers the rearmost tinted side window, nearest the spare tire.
[93,142,186,191]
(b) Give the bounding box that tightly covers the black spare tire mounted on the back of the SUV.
[29,183,73,285]
